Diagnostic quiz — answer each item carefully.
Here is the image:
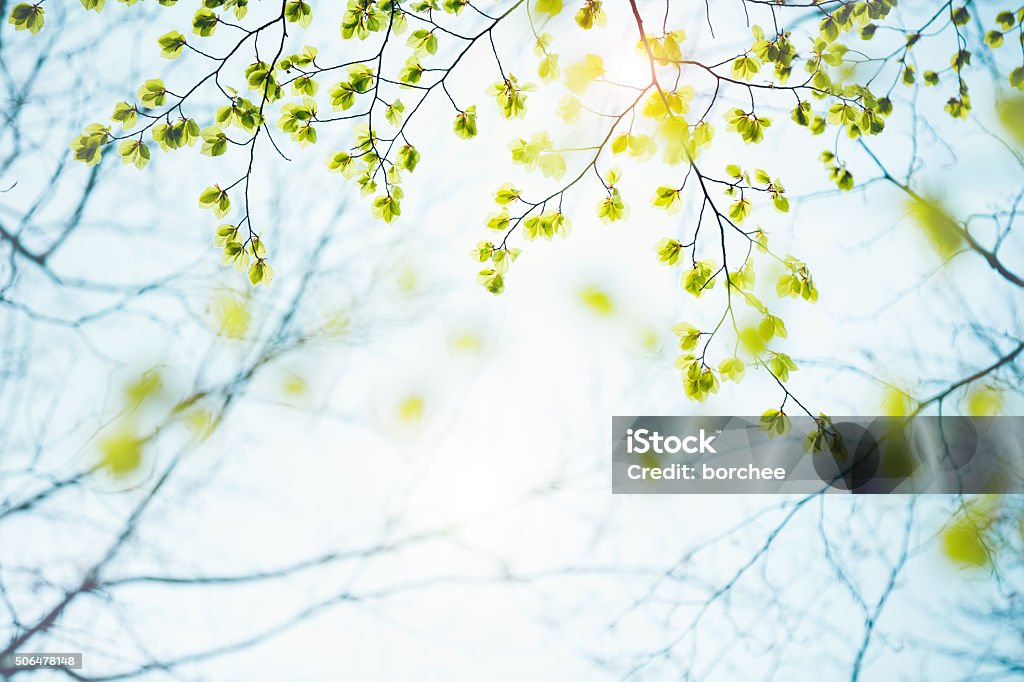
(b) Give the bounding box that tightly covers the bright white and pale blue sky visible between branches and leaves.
[0,2,1024,680]
